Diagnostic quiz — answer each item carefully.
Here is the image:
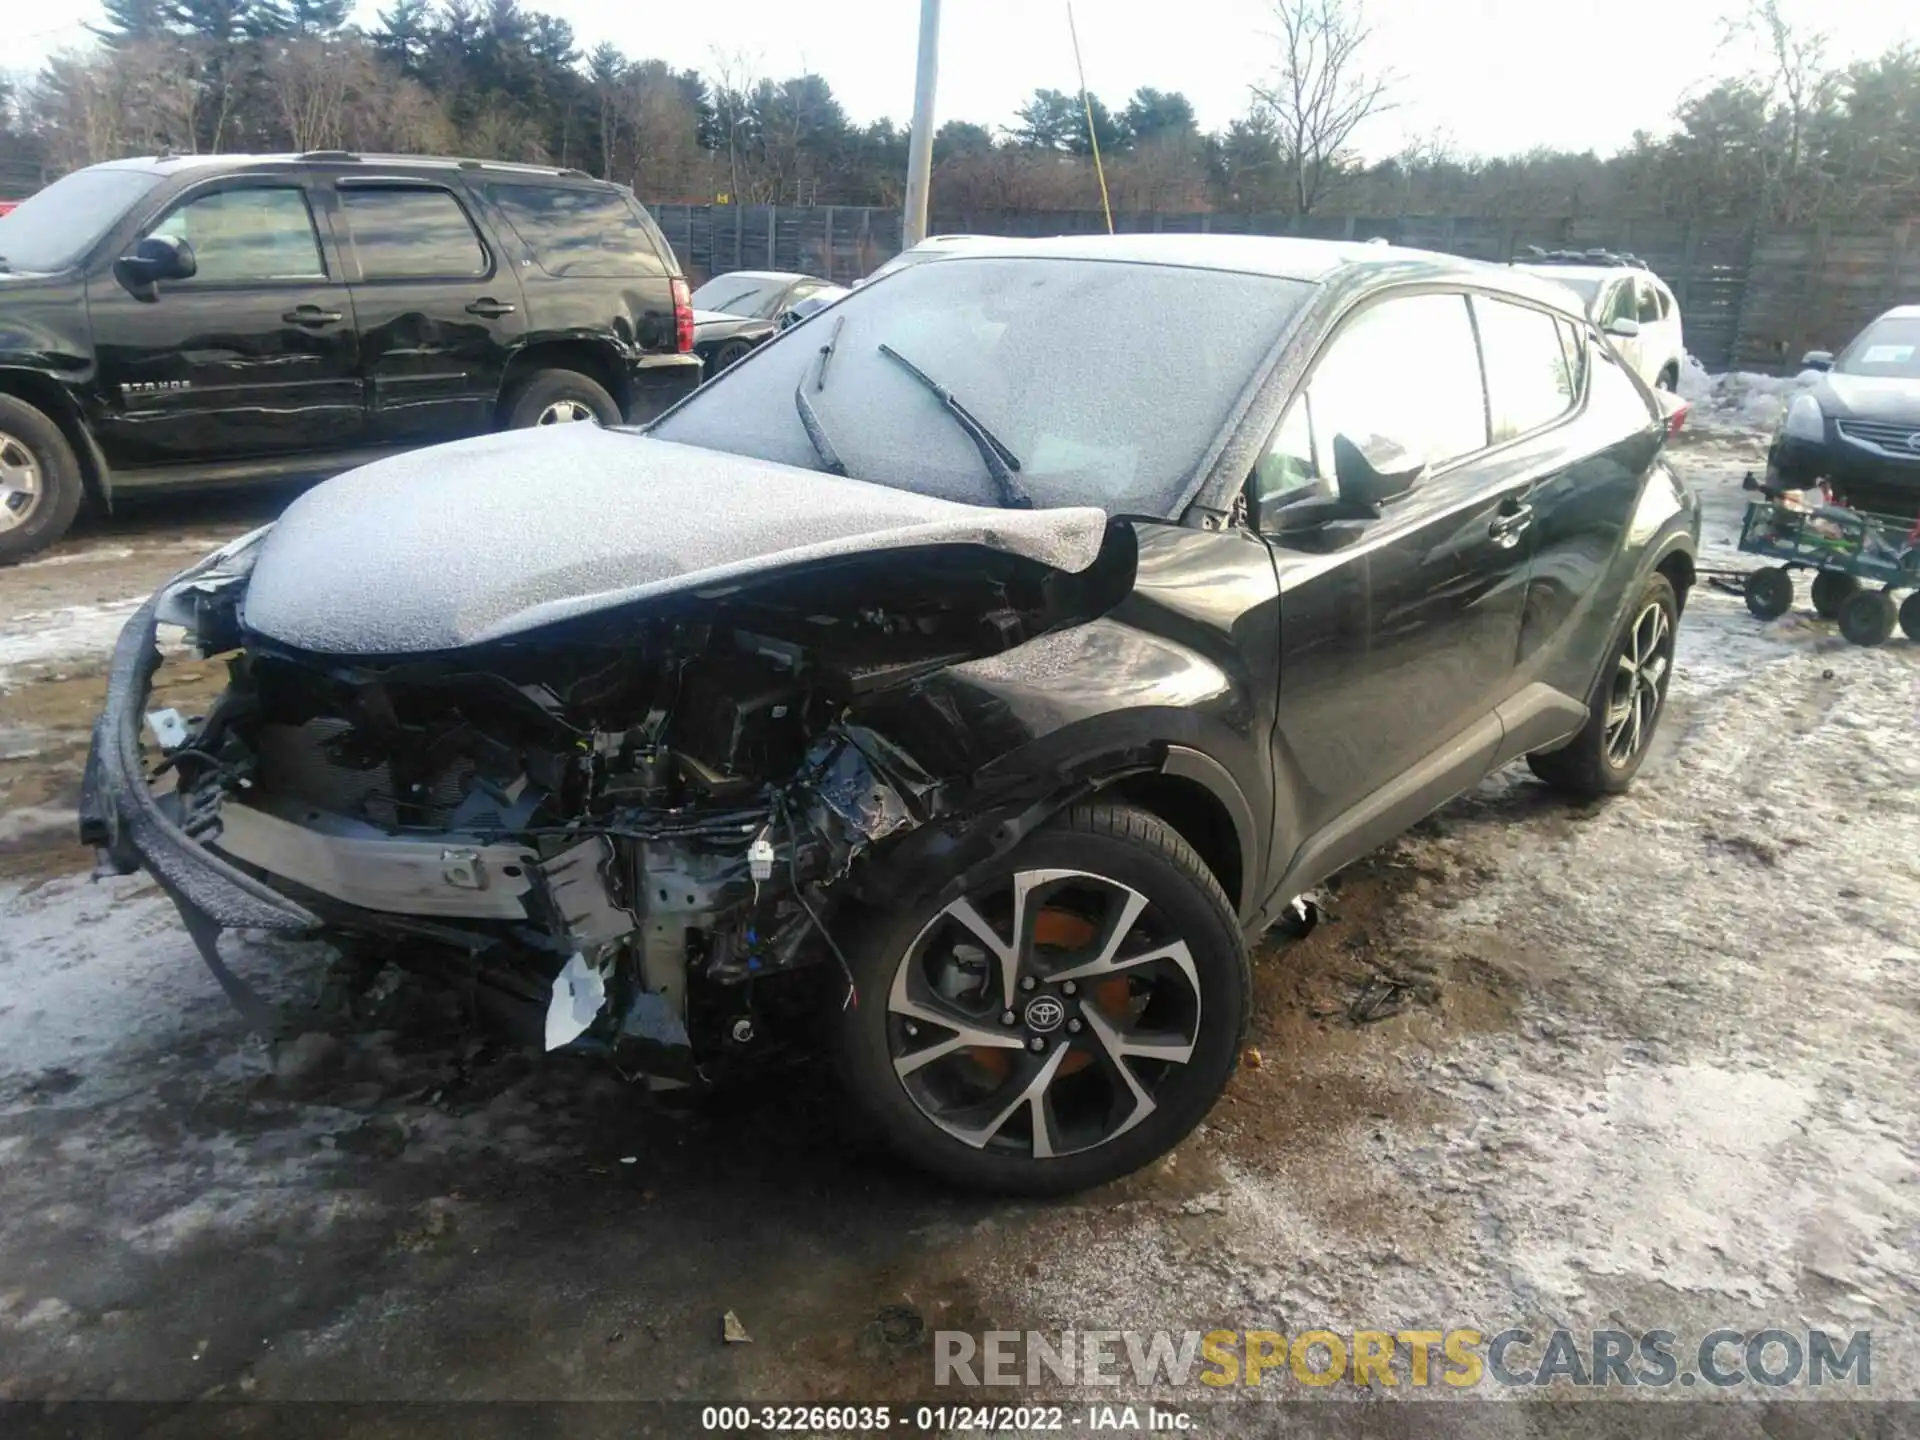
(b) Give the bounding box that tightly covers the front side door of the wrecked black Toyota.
[1250,292,1530,876]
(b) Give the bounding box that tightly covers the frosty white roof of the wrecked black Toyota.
[906,234,1586,317]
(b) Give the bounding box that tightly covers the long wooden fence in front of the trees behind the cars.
[651,205,1920,371]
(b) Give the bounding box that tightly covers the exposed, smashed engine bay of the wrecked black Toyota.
[161,545,1133,1077]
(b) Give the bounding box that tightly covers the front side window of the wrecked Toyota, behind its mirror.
[1308,296,1486,474]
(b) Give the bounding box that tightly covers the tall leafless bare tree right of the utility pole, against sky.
[1254,0,1394,215]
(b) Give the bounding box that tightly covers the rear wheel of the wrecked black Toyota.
[1526,574,1680,799]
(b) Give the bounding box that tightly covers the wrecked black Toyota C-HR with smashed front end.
[83,236,1697,1192]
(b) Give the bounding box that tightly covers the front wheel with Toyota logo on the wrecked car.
[837,804,1252,1194]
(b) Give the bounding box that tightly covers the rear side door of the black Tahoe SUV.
[334,175,526,445]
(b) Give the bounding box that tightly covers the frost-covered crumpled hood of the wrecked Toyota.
[244,424,1106,655]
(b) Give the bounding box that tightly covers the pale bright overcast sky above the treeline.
[15,0,1920,156]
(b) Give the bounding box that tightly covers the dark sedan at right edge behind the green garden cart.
[1766,305,1920,520]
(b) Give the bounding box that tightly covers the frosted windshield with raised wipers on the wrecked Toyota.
[653,257,1311,516]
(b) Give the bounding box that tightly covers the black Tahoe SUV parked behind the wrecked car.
[0,152,701,561]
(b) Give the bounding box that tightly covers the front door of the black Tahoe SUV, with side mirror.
[86,175,367,470]
